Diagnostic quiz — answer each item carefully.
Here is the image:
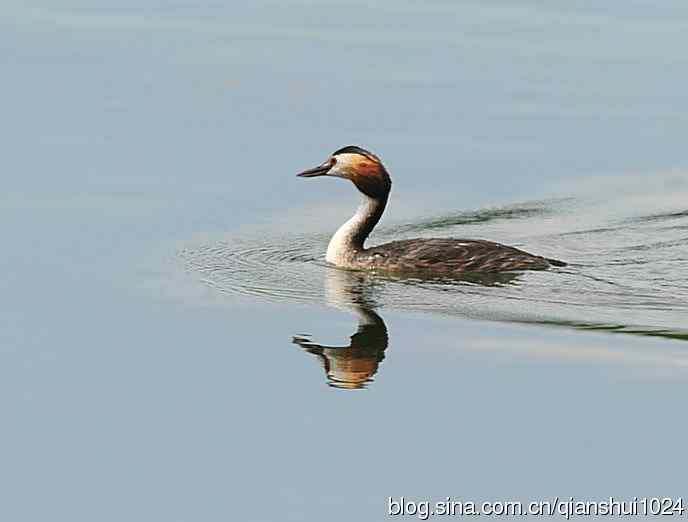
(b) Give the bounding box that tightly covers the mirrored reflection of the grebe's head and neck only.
[292,268,389,389]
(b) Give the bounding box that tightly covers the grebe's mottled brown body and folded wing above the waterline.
[364,239,562,274]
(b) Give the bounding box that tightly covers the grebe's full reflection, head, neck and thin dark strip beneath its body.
[292,267,518,390]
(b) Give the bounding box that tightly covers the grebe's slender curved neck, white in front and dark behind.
[325,193,387,267]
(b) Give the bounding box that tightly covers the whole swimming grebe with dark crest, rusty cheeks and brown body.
[298,145,566,276]
